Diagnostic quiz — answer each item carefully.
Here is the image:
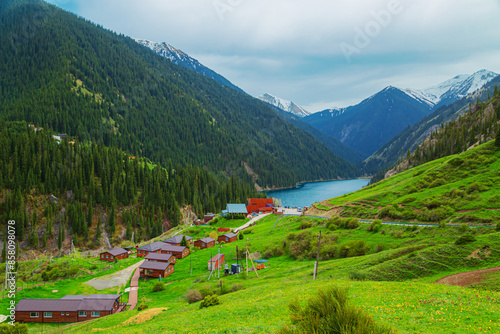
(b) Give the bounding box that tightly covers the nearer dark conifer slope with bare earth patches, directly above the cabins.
[0,122,262,254]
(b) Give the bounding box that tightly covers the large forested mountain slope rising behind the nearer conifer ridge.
[0,1,357,187]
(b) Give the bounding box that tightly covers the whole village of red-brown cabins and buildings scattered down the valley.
[15,198,281,323]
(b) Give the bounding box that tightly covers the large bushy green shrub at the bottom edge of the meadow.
[278,287,391,334]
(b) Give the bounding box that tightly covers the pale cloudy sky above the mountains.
[47,0,500,112]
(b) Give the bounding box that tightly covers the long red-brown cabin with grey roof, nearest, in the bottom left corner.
[15,295,125,323]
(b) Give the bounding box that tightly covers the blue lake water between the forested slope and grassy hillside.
[267,179,370,207]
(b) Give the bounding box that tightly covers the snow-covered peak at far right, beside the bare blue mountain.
[403,70,498,108]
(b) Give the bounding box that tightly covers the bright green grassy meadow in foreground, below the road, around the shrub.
[10,215,500,333]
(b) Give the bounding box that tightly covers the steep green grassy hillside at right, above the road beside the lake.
[316,141,500,225]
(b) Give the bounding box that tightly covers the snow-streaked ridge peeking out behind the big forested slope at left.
[135,38,243,92]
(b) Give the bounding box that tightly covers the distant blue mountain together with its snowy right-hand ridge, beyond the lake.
[304,70,498,155]
